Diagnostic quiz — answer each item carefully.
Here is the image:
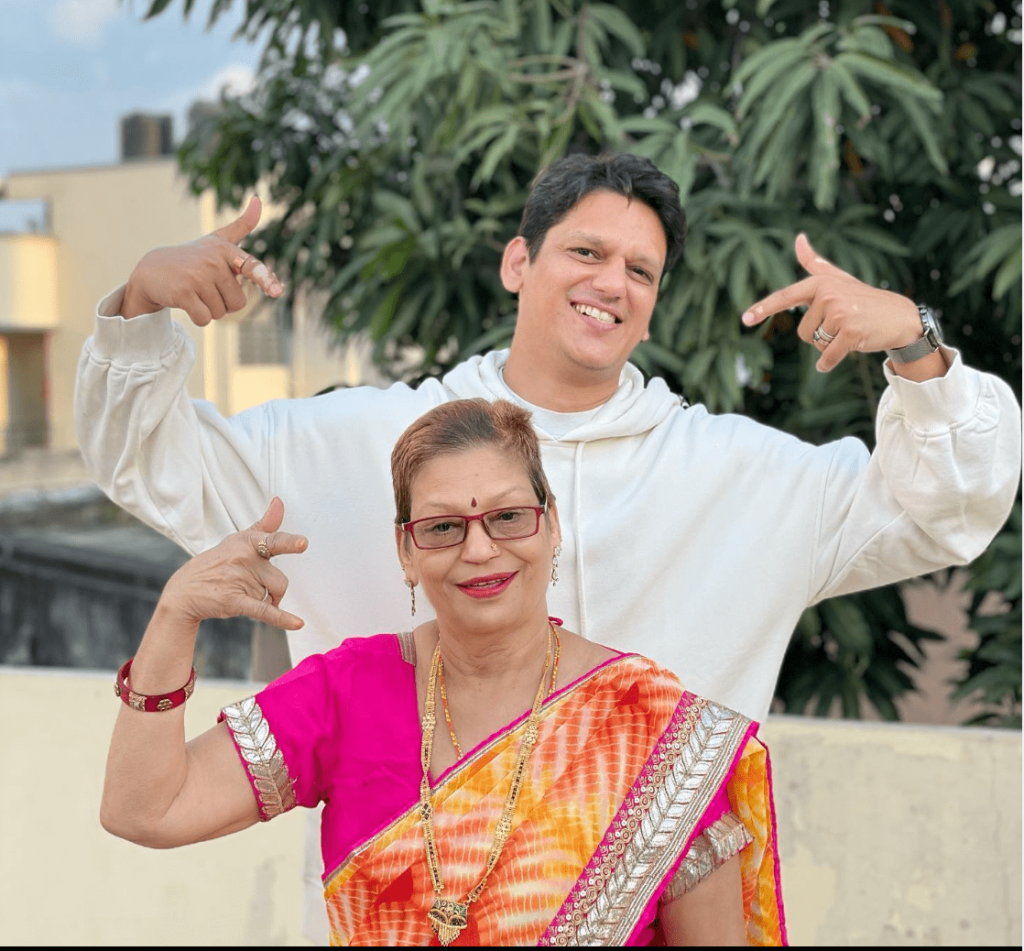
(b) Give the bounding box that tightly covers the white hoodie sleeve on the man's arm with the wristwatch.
[809,350,1021,604]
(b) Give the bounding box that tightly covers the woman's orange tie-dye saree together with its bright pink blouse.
[221,635,785,948]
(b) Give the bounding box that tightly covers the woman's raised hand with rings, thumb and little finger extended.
[160,498,308,631]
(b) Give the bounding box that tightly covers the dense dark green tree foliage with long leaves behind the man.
[147,0,1021,718]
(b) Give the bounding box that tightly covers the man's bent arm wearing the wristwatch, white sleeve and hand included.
[743,234,1021,603]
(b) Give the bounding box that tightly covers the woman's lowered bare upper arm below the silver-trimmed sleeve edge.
[658,853,748,947]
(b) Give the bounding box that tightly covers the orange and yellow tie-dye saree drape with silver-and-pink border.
[225,638,785,947]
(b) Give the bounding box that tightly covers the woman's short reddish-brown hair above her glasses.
[391,397,554,525]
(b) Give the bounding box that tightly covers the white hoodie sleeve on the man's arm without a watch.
[75,287,290,554]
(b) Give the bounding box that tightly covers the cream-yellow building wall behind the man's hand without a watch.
[0,159,361,449]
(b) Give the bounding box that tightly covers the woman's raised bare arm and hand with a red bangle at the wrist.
[100,499,306,849]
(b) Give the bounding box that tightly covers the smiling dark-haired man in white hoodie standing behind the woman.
[76,155,1020,937]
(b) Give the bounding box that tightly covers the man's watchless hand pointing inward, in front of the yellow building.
[121,196,284,327]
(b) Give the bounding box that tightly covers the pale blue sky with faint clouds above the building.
[0,0,260,180]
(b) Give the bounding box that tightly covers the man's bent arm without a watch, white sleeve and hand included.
[75,199,282,554]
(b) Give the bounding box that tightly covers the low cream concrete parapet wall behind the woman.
[0,667,1021,946]
